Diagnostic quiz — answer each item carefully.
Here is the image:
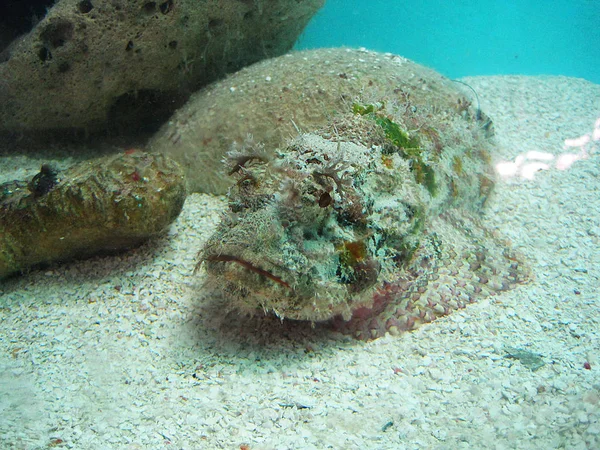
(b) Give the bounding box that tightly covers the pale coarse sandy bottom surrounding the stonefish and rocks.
[0,76,600,450]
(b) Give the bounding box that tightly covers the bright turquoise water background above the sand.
[296,0,600,84]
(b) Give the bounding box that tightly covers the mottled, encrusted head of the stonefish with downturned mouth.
[200,135,396,321]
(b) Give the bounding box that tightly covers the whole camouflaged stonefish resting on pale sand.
[199,100,528,339]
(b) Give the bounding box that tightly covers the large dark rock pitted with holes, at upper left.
[0,0,324,132]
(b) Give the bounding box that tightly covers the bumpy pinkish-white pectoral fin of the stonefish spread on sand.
[332,209,531,340]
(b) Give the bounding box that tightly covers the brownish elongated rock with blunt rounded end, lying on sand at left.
[0,151,185,278]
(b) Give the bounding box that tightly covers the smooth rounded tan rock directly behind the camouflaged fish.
[148,48,491,194]
